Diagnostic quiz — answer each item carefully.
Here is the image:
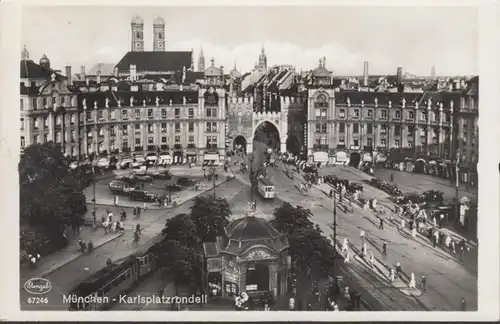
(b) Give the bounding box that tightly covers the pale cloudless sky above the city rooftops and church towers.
[20,6,478,76]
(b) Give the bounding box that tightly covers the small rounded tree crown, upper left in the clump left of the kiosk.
[162,214,200,247]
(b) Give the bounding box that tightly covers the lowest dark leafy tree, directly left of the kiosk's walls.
[152,240,203,295]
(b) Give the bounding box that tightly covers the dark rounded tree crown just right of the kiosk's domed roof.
[271,202,313,234]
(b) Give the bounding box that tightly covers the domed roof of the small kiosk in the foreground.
[224,216,282,241]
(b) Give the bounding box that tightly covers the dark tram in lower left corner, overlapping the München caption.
[68,254,156,311]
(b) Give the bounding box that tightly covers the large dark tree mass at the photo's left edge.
[19,142,87,236]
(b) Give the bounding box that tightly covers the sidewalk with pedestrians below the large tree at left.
[20,227,123,289]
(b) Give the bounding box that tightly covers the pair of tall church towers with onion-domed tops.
[130,16,166,52]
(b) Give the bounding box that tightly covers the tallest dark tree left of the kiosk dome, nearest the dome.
[191,196,231,242]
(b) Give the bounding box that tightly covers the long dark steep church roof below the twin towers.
[116,51,193,73]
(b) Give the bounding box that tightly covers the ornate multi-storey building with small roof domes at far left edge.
[20,48,80,157]
